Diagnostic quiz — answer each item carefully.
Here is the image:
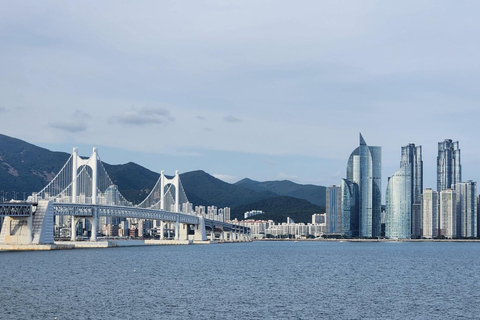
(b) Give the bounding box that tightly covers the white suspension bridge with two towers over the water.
[0,148,250,245]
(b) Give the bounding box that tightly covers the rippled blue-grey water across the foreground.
[0,242,480,319]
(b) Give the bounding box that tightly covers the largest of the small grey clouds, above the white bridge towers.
[110,108,175,126]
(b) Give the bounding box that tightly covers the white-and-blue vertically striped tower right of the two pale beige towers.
[455,180,477,238]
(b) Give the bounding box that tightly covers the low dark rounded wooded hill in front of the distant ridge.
[231,196,325,223]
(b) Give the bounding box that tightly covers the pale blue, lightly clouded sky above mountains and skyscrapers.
[0,0,480,189]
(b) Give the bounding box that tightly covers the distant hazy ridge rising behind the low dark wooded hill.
[235,178,326,207]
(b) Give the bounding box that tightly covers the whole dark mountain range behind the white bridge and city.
[0,134,325,222]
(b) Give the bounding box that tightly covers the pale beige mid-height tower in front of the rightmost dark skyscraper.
[438,189,457,239]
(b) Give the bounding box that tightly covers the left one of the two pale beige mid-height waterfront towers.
[420,188,436,239]
